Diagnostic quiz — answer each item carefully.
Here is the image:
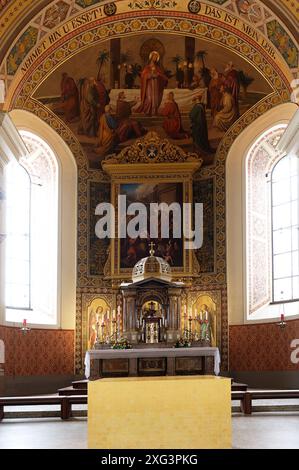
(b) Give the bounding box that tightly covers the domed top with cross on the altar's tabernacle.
[132,243,172,282]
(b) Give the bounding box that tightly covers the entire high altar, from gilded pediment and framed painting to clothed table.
[83,132,221,379]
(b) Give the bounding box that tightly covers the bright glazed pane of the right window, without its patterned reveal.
[271,155,299,302]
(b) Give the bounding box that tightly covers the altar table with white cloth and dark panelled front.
[85,347,220,380]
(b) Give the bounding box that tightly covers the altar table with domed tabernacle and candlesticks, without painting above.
[85,243,220,379]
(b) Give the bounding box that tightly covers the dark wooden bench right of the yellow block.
[232,390,299,415]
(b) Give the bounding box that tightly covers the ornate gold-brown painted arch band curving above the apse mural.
[5,1,293,109]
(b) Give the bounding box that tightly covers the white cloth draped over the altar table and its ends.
[84,348,221,379]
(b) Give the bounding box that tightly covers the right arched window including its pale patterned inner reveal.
[246,125,299,319]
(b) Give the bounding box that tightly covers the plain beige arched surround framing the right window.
[226,103,298,325]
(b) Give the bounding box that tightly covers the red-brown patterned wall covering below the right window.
[229,320,299,372]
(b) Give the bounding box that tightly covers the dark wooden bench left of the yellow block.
[0,395,87,421]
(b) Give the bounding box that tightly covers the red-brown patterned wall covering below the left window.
[0,326,74,376]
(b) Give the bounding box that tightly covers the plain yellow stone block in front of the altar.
[88,376,232,449]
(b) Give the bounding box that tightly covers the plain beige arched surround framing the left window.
[10,110,77,329]
